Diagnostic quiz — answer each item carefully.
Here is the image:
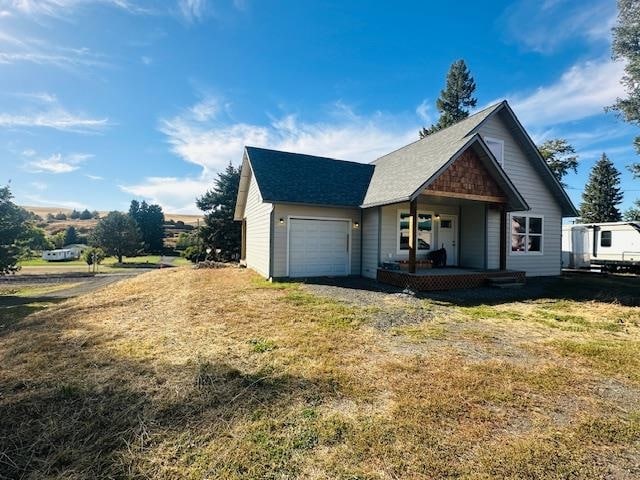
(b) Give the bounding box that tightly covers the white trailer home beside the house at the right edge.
[562,222,640,271]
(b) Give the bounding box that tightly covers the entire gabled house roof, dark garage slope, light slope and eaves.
[235,101,577,219]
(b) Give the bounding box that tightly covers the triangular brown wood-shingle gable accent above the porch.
[424,148,507,203]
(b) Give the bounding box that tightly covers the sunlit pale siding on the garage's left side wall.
[244,175,273,277]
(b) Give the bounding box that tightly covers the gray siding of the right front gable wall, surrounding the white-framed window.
[479,115,562,276]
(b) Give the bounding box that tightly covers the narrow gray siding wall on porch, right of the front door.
[459,202,486,268]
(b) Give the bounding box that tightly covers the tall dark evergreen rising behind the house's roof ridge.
[419,60,477,138]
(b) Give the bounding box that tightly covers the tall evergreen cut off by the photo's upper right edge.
[609,0,640,156]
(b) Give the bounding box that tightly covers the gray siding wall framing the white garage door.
[271,203,362,278]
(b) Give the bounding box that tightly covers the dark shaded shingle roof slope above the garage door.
[246,147,374,207]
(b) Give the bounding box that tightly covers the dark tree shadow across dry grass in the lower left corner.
[0,322,340,478]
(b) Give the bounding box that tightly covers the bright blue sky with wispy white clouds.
[0,0,640,213]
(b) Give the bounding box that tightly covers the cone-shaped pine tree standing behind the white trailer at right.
[580,153,622,223]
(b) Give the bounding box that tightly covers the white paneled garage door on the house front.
[289,218,351,277]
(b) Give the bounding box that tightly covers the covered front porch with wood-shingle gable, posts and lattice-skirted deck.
[376,144,525,291]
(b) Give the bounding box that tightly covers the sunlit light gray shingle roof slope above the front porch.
[363,102,502,206]
